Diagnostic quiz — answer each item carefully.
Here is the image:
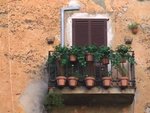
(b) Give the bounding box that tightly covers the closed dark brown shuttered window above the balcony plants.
[72,19,108,46]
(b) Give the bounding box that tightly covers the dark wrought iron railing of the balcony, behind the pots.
[47,51,136,88]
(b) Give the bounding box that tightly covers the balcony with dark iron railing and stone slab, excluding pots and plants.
[48,44,136,105]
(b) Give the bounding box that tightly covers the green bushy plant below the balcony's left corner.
[44,91,64,111]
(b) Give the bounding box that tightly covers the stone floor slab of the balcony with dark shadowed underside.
[52,87,135,106]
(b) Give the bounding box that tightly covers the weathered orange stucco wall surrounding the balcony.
[0,0,150,113]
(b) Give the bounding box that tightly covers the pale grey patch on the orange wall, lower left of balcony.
[20,80,48,113]
